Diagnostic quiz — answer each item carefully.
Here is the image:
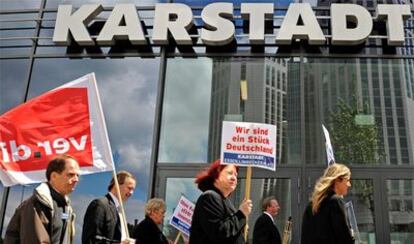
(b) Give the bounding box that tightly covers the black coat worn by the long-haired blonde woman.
[301,193,354,244]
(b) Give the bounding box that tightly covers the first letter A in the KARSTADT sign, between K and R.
[96,4,146,45]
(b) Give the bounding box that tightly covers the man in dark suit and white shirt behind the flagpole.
[82,171,136,244]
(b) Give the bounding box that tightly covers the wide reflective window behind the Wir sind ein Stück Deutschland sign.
[158,58,414,165]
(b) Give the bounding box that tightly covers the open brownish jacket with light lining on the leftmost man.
[4,183,75,244]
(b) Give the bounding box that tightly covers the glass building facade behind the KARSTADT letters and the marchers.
[0,0,414,244]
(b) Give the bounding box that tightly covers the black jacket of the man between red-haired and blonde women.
[253,213,282,244]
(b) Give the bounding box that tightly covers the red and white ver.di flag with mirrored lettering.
[0,73,114,186]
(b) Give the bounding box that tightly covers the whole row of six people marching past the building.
[4,155,354,244]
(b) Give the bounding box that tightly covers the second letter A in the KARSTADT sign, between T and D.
[276,3,325,45]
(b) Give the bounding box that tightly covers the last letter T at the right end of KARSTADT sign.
[377,4,411,46]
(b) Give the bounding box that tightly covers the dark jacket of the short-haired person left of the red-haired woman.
[132,216,168,244]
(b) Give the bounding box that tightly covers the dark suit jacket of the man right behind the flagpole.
[82,193,121,244]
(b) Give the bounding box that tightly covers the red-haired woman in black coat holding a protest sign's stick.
[190,160,252,244]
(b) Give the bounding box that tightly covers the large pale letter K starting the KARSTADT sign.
[53,4,103,46]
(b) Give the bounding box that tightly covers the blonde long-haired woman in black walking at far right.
[301,164,354,244]
